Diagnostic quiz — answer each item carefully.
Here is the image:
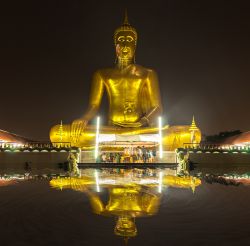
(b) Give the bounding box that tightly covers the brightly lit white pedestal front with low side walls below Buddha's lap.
[81,134,176,165]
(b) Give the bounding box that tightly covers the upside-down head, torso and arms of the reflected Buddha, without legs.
[88,185,161,238]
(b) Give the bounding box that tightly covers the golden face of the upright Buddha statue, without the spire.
[115,31,136,60]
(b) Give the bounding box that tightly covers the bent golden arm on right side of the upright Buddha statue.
[142,70,162,125]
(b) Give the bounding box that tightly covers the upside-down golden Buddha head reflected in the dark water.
[115,216,137,238]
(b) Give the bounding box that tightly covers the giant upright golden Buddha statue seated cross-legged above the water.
[50,10,201,148]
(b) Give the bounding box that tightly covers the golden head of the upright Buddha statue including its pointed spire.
[114,11,137,60]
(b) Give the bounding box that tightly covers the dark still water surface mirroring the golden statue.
[0,167,250,246]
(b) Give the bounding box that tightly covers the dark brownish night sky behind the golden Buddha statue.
[0,0,250,140]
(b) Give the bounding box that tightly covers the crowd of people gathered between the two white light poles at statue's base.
[96,146,156,163]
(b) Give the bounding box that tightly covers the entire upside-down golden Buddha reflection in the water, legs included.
[50,170,201,239]
